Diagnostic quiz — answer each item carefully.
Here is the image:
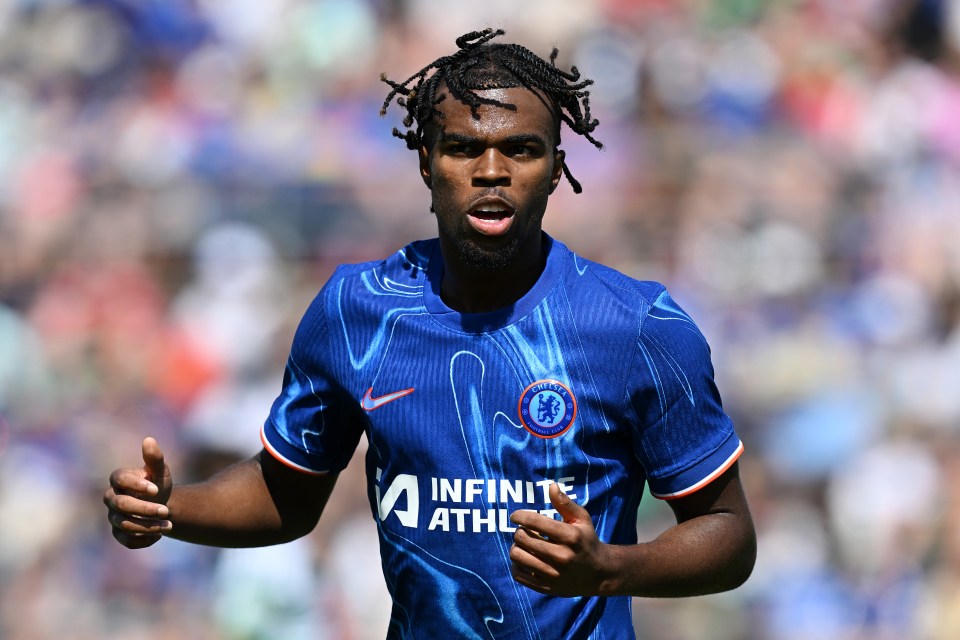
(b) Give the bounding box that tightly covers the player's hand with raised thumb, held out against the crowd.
[103,438,173,549]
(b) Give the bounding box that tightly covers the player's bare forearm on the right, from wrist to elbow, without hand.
[600,513,756,598]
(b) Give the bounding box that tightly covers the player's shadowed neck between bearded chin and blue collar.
[440,234,547,313]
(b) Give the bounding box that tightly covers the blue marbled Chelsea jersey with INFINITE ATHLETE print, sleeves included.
[261,236,742,640]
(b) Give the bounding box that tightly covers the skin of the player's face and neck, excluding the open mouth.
[420,88,564,313]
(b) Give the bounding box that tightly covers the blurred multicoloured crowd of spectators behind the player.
[0,0,960,640]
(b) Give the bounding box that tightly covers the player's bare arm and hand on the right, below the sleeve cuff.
[510,464,756,598]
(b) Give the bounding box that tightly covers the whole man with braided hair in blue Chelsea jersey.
[104,30,755,639]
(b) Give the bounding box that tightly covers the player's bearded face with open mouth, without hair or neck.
[420,88,563,270]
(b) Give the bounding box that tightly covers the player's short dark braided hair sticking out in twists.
[380,29,603,193]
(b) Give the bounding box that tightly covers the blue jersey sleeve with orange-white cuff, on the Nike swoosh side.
[260,283,363,474]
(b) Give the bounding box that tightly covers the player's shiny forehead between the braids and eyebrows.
[437,87,556,141]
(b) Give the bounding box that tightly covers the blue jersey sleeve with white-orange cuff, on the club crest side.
[628,291,743,499]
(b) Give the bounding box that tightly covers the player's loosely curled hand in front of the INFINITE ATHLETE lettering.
[510,483,611,596]
